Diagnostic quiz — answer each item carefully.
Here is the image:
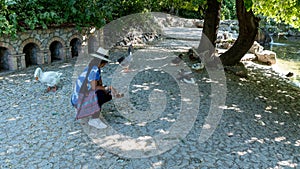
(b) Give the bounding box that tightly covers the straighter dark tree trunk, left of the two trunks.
[198,0,221,53]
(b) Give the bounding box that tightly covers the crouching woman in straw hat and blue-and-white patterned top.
[71,48,122,129]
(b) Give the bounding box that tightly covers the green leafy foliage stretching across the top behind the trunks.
[0,0,300,36]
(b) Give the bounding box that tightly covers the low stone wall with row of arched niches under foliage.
[0,28,99,72]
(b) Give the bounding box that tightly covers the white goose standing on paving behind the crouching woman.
[34,67,62,92]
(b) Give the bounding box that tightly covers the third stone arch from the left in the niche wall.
[47,37,66,63]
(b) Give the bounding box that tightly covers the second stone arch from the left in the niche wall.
[20,38,43,67]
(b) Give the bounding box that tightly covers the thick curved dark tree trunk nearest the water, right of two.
[220,0,259,66]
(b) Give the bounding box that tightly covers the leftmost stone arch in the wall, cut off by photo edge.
[0,42,16,72]
